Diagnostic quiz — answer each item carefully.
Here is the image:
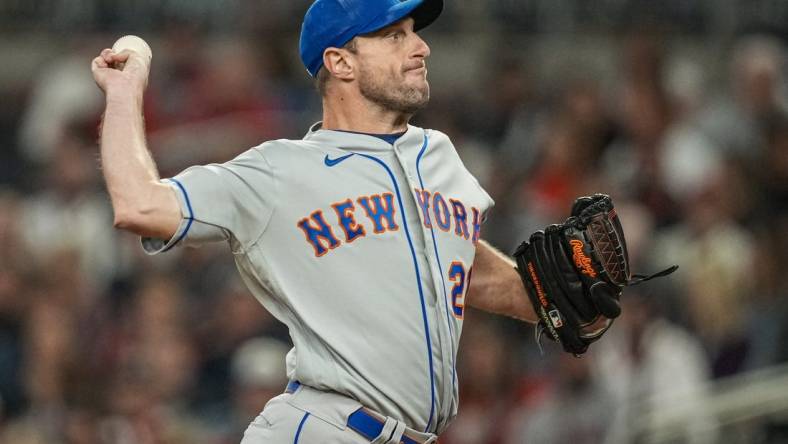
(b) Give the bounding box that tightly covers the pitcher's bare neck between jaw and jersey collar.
[323,93,411,134]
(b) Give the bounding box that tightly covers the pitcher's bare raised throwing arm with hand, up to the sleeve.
[91,44,181,239]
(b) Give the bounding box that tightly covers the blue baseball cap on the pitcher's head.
[300,0,443,77]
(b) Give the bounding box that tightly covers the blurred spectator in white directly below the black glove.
[592,288,716,443]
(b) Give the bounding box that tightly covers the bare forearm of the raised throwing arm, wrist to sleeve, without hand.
[100,88,177,238]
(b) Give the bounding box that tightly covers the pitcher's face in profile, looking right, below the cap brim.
[357,18,430,114]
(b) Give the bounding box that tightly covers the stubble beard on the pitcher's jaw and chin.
[359,65,430,116]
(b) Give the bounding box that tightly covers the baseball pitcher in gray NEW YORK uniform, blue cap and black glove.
[92,0,672,444]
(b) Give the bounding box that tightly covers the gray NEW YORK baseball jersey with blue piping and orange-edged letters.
[143,124,493,433]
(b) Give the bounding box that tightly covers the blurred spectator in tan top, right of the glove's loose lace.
[655,160,753,376]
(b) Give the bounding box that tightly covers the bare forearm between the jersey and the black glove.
[466,241,536,322]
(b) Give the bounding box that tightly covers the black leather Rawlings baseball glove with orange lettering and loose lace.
[514,194,678,356]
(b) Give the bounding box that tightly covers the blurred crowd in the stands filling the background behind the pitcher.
[0,0,788,444]
